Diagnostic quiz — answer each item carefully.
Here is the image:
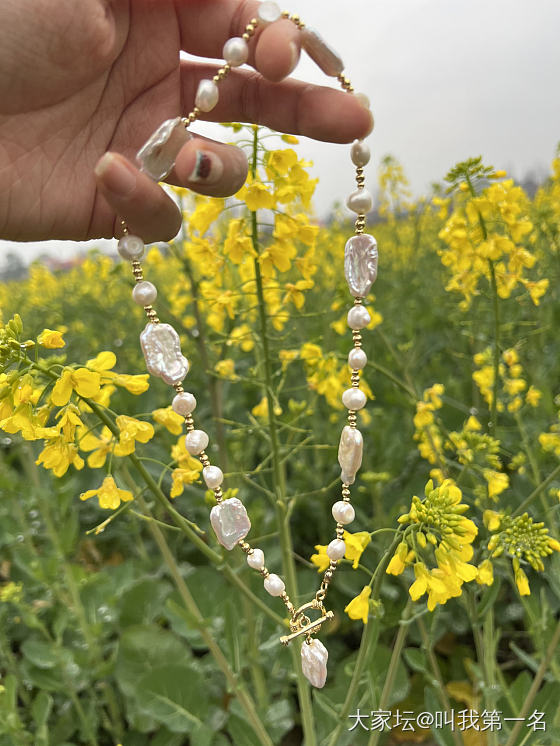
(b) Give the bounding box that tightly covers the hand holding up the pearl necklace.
[0,0,373,241]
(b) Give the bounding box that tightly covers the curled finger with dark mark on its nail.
[166,137,248,197]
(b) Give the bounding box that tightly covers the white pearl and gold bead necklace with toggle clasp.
[118,1,377,688]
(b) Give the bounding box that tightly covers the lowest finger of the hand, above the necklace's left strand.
[95,153,182,243]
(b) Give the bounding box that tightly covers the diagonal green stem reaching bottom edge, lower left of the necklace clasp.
[130,480,274,746]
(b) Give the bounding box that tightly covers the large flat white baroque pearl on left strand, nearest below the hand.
[140,322,189,386]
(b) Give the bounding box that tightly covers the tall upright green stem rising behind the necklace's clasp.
[251,127,317,746]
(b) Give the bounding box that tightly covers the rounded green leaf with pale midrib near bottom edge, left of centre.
[136,664,209,733]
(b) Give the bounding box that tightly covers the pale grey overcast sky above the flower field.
[0,0,560,260]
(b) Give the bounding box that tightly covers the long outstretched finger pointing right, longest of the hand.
[181,61,373,143]
